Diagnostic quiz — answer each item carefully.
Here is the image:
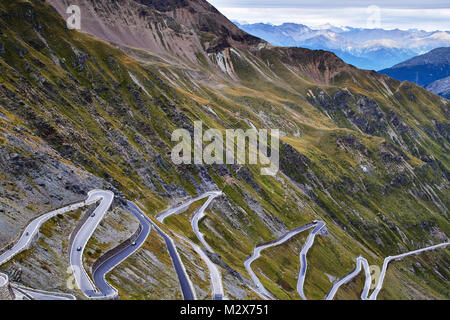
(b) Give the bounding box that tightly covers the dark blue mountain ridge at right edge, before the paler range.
[380,48,450,99]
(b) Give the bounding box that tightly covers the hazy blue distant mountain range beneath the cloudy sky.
[234,22,450,70]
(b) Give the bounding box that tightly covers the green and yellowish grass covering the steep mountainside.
[0,0,450,299]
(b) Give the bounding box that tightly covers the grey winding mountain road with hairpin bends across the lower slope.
[0,186,449,300]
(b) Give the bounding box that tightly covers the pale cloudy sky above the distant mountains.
[208,0,450,31]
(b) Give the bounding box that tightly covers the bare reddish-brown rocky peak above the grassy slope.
[49,0,262,62]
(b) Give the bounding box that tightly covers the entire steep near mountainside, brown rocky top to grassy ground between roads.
[0,0,450,299]
